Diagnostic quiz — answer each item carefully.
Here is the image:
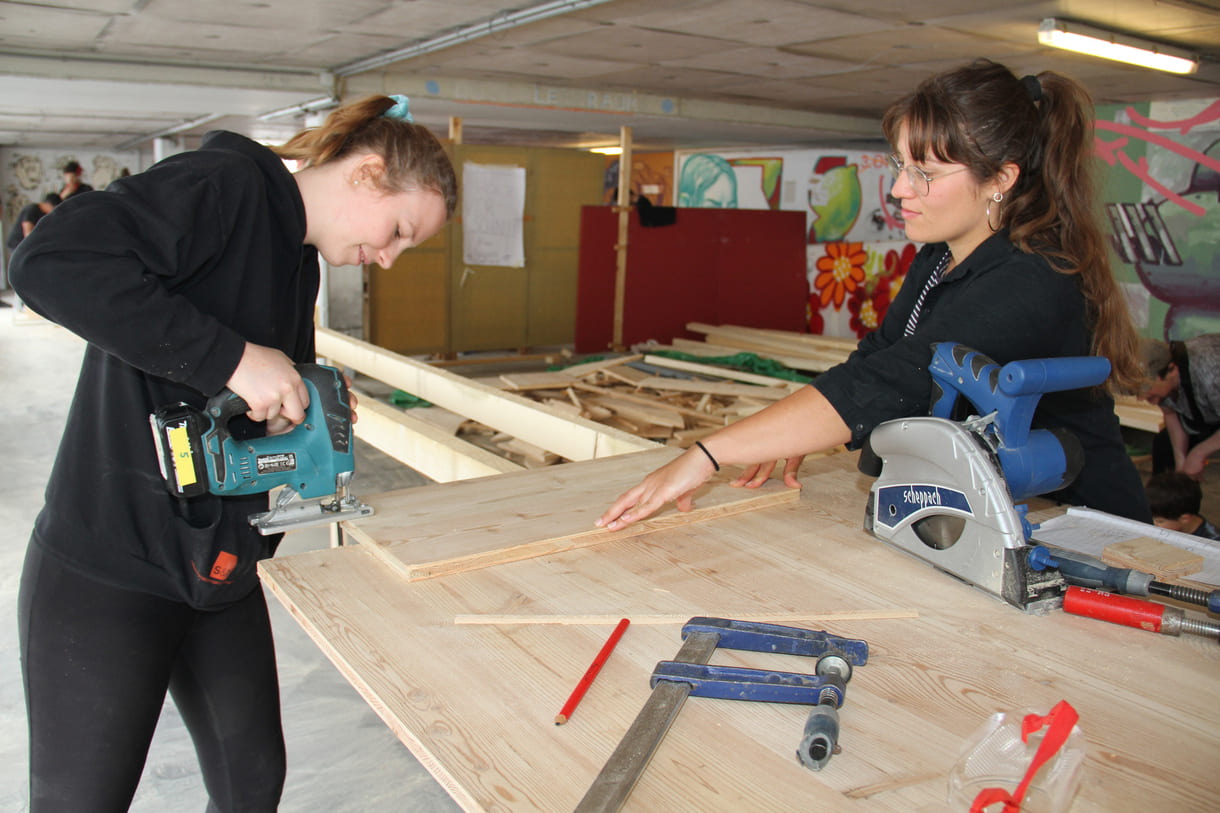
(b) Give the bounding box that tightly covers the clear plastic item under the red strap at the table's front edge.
[949,709,1086,813]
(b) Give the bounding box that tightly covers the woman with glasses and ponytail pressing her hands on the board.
[598,60,1152,530]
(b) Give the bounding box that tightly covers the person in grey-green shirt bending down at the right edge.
[1142,333,1220,479]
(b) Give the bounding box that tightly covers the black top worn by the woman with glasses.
[813,232,1152,522]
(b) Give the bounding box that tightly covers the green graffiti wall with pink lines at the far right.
[1097,99,1220,339]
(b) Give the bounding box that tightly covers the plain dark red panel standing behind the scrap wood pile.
[576,206,809,353]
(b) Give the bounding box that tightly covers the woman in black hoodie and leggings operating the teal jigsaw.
[10,95,456,813]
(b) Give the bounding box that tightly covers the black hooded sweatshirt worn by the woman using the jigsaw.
[10,132,318,608]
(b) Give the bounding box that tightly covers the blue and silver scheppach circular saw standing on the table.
[859,342,1110,613]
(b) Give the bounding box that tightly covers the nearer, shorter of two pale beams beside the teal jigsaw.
[353,392,521,482]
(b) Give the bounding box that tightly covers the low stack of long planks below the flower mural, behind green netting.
[650,322,856,372]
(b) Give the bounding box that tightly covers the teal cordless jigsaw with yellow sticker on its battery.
[149,364,373,535]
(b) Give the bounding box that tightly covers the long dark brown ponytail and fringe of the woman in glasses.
[882,60,1143,392]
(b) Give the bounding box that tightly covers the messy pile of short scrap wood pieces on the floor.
[446,354,803,468]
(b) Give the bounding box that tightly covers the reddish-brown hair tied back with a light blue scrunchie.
[272,95,458,217]
